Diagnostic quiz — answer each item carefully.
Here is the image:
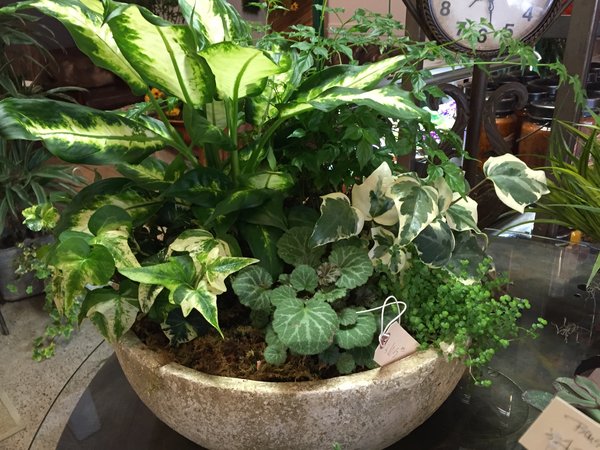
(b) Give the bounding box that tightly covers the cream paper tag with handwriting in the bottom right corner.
[519,397,600,450]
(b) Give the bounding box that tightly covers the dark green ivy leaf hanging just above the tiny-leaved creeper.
[446,230,487,284]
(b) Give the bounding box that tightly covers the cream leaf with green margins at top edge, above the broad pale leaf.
[179,0,250,48]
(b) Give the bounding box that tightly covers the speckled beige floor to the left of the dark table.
[0,297,112,450]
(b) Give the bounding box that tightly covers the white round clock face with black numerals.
[423,0,559,52]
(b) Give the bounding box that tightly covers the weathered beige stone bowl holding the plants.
[115,332,464,450]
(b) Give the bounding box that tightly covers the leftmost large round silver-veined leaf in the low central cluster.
[231,266,273,310]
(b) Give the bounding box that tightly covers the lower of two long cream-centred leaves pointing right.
[281,84,429,120]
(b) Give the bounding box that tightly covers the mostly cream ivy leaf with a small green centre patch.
[352,162,398,226]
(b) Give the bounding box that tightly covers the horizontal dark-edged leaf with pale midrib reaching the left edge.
[0,98,168,164]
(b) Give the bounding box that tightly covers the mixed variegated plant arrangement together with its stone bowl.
[0,0,547,449]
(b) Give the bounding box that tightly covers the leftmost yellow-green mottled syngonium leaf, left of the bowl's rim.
[49,237,115,311]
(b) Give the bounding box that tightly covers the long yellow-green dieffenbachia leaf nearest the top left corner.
[23,0,147,94]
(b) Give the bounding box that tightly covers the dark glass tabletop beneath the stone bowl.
[57,237,600,450]
